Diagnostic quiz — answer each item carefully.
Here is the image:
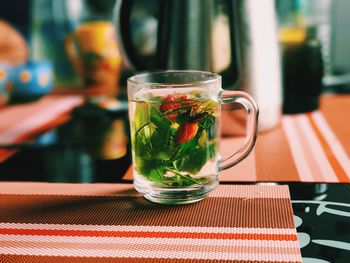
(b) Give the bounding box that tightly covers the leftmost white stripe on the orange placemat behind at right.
[282,116,314,182]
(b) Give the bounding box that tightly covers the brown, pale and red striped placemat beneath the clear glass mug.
[0,183,301,262]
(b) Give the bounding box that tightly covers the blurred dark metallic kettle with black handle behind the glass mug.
[116,0,240,87]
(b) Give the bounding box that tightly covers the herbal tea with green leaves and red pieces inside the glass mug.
[129,91,220,187]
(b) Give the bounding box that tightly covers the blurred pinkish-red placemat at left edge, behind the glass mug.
[0,95,84,162]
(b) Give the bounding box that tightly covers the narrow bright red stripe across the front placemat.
[0,228,297,241]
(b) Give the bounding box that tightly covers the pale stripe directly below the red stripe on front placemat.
[0,235,299,248]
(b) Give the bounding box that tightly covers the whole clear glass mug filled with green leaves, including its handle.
[127,70,258,204]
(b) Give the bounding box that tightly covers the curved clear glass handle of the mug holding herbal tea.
[219,90,259,171]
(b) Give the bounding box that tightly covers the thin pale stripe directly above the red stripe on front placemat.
[0,223,296,235]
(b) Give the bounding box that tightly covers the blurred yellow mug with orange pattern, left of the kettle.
[65,21,122,95]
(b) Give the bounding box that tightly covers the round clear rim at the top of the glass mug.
[127,70,221,87]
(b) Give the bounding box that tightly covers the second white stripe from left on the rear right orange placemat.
[297,115,339,182]
